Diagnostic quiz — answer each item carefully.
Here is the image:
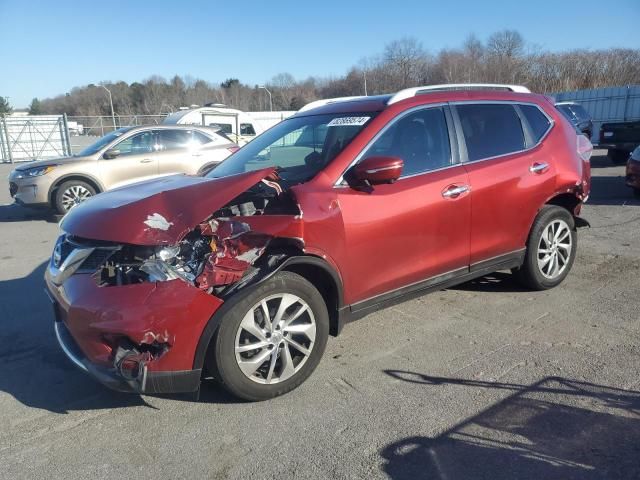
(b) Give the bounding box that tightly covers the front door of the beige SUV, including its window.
[98,130,158,189]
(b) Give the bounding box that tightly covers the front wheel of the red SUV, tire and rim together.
[206,272,329,401]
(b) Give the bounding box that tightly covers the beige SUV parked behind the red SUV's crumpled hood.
[9,126,238,214]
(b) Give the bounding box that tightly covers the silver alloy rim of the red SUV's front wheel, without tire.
[235,293,316,384]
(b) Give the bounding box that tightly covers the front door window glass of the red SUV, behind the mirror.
[362,108,451,177]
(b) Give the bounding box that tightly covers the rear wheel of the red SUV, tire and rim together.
[514,205,578,290]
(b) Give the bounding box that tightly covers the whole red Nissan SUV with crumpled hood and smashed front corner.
[46,85,591,400]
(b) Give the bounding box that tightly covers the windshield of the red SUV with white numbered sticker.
[207,112,376,185]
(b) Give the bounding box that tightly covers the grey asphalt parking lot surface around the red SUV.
[0,152,640,479]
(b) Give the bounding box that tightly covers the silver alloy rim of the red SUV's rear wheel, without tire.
[538,219,573,280]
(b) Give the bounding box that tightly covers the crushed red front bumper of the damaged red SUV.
[45,269,222,394]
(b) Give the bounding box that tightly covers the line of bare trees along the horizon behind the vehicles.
[39,30,640,115]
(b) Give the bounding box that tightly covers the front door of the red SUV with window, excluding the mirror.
[338,106,471,303]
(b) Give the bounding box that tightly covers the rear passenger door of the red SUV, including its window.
[453,102,555,268]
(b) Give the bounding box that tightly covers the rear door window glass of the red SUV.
[456,104,525,162]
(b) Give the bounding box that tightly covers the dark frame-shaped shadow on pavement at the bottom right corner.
[380,370,640,480]
